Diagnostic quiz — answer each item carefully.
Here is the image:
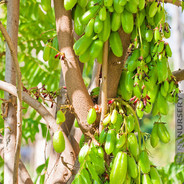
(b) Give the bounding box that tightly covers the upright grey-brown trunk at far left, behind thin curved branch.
[4,0,19,184]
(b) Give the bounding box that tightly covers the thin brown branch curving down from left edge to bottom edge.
[0,21,22,184]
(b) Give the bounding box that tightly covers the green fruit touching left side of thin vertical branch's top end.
[89,40,103,59]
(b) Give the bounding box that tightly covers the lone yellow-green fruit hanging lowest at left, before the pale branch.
[53,131,65,153]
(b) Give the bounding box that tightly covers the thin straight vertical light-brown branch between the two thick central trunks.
[99,41,108,133]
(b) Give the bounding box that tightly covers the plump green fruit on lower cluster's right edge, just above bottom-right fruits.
[139,151,150,173]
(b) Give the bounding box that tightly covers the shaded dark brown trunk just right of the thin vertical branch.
[107,29,130,98]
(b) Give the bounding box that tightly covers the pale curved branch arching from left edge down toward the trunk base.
[0,80,75,183]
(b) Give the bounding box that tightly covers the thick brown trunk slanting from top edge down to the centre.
[54,0,93,132]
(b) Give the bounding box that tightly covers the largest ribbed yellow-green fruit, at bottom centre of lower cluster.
[110,151,127,184]
